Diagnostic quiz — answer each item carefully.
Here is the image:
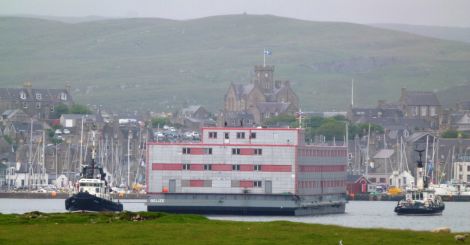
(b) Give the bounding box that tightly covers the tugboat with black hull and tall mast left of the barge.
[65,131,123,212]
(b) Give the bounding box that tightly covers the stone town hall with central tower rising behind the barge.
[219,65,299,127]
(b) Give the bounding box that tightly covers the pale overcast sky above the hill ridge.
[0,0,470,27]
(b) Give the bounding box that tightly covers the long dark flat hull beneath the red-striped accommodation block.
[147,193,346,216]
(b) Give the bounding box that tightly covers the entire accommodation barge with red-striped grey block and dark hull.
[146,128,347,215]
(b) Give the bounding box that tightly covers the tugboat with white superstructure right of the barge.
[395,150,445,215]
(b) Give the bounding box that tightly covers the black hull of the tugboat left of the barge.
[65,192,123,212]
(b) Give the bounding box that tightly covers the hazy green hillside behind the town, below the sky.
[0,15,470,111]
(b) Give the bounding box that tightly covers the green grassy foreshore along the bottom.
[0,212,468,245]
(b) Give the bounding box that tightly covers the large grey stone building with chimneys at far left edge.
[0,82,73,119]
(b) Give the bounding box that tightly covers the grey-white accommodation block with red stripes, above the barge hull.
[146,128,347,198]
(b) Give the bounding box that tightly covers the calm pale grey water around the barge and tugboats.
[0,199,470,232]
